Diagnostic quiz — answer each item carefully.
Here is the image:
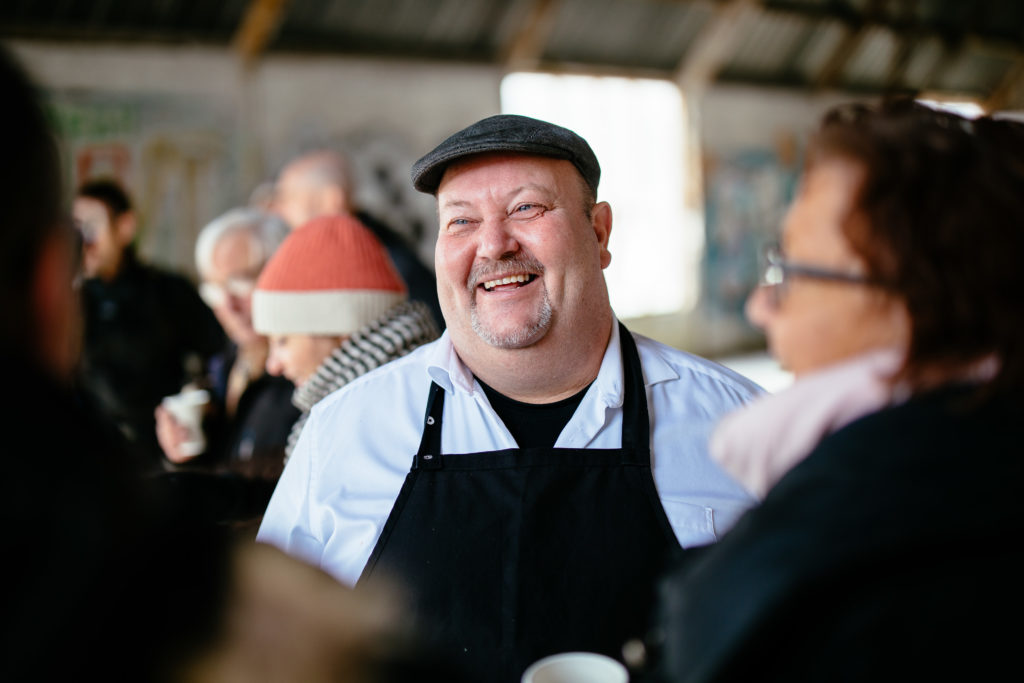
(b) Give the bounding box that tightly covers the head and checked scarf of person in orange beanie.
[253,215,438,453]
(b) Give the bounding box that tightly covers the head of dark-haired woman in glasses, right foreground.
[748,100,1024,390]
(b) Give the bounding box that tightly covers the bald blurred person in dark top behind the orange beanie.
[271,150,444,330]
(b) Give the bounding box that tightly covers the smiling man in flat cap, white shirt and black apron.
[259,116,759,681]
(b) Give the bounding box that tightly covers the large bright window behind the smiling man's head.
[501,73,703,318]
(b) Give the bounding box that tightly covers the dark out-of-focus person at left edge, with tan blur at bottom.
[0,45,468,683]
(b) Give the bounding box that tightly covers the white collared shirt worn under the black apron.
[257,325,761,585]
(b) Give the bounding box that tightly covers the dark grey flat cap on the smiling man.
[413,114,601,195]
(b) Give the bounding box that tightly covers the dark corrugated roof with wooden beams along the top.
[0,0,1024,105]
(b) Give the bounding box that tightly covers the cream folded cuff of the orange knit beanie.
[253,290,408,335]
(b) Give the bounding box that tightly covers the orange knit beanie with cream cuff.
[253,216,407,335]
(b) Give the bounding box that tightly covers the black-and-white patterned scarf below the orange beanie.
[285,301,438,462]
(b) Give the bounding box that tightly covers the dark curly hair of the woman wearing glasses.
[807,99,1024,393]
